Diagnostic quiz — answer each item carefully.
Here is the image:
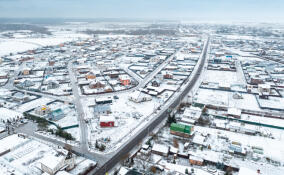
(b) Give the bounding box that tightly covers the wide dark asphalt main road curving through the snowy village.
[90,37,210,175]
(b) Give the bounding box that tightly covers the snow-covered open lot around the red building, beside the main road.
[88,93,160,150]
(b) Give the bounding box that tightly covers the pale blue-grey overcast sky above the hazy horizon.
[0,0,284,21]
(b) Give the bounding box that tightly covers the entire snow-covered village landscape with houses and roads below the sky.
[0,2,284,175]
